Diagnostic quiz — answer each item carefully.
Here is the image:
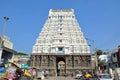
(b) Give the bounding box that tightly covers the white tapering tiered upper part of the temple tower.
[32,9,90,54]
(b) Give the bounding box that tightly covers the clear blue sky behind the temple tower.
[0,0,120,54]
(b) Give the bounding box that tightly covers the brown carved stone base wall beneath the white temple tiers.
[31,54,92,75]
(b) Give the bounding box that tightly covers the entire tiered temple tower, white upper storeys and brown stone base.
[31,9,92,75]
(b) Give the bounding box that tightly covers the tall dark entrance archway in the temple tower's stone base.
[56,57,65,76]
